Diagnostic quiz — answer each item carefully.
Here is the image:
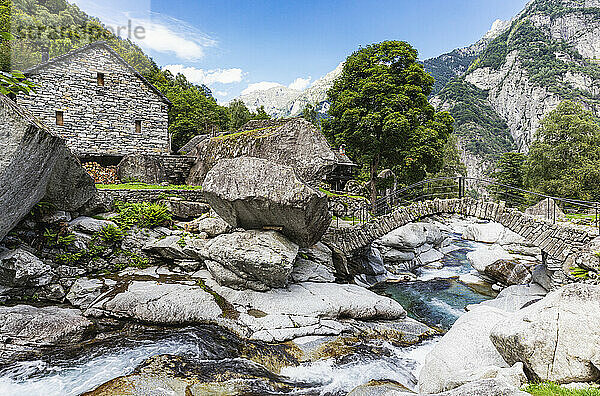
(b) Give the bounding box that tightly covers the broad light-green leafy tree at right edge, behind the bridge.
[525,101,600,200]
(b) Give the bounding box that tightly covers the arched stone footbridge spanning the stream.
[324,198,598,285]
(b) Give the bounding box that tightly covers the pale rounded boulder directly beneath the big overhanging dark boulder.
[204,230,298,291]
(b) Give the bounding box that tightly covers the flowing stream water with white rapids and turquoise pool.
[0,236,491,396]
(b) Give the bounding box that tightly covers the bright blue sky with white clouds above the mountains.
[71,0,527,103]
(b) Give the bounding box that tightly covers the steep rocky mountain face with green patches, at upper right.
[425,0,600,176]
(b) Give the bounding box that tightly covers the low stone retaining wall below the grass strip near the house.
[83,190,207,215]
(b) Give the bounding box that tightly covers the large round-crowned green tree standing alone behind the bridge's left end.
[323,41,453,201]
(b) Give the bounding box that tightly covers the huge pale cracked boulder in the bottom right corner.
[490,284,600,383]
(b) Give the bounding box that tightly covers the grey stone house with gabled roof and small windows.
[17,42,170,160]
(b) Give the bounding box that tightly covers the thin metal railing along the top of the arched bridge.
[353,176,600,232]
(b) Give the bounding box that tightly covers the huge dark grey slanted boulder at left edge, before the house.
[0,94,96,239]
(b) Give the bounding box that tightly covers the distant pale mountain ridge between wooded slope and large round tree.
[238,63,344,118]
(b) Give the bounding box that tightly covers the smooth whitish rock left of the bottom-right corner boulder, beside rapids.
[419,306,509,393]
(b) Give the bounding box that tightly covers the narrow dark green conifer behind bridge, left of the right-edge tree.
[491,152,527,206]
